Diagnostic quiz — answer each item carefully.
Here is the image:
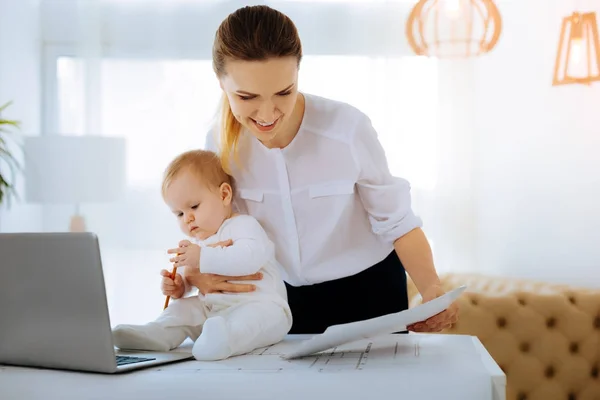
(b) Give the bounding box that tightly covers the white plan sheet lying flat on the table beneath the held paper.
[153,334,481,373]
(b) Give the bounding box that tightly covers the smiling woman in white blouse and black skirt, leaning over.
[183,6,457,333]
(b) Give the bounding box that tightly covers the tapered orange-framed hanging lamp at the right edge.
[552,12,600,86]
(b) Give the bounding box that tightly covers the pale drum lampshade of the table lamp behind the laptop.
[23,135,126,204]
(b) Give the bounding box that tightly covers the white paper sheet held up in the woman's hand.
[283,285,467,359]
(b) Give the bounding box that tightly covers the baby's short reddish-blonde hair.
[161,150,233,197]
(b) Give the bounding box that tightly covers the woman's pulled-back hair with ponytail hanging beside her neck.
[213,5,302,173]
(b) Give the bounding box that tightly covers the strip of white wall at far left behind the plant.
[0,0,42,232]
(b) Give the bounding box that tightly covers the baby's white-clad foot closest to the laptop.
[113,323,186,351]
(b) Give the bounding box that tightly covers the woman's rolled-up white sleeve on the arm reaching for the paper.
[351,115,423,243]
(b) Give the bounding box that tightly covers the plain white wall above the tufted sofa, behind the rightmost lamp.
[474,0,600,287]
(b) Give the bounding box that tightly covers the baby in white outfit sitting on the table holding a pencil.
[113,150,292,361]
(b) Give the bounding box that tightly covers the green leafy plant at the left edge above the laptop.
[0,102,20,205]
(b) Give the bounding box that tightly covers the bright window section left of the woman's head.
[58,57,220,187]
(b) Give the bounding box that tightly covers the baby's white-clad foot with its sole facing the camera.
[192,316,232,361]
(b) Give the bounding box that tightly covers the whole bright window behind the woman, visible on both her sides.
[57,56,437,189]
